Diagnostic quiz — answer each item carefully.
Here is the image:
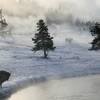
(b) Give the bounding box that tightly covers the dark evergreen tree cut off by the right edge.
[89,23,100,50]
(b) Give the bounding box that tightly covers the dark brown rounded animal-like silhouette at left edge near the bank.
[0,71,11,87]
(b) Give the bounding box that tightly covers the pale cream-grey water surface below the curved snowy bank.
[9,75,100,100]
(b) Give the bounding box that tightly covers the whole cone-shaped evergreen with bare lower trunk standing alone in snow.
[32,19,55,58]
